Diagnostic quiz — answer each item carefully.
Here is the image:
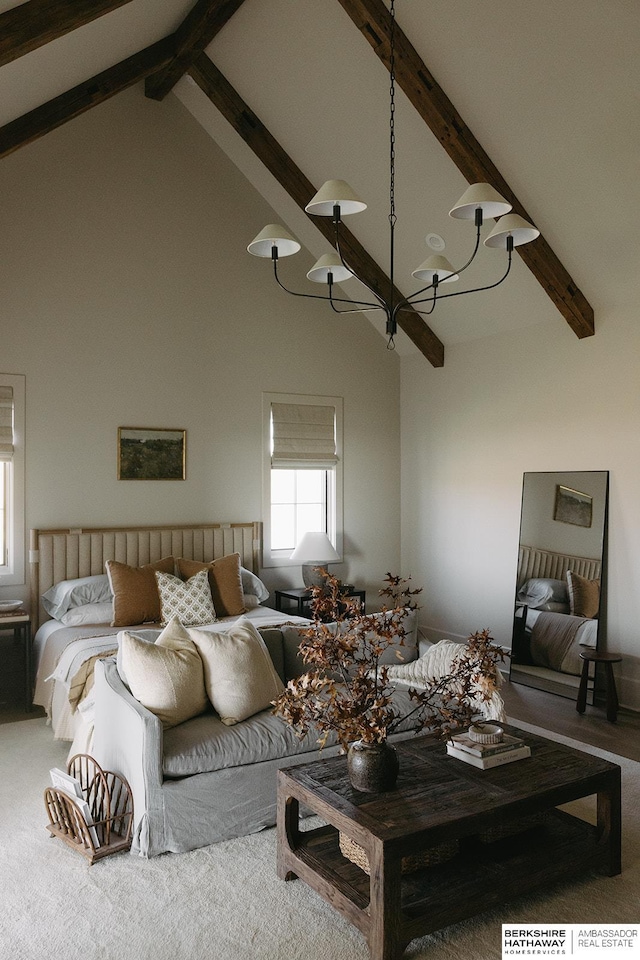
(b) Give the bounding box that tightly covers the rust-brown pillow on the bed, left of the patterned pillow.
[107,557,174,627]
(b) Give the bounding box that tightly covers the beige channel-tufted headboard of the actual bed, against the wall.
[29,521,262,626]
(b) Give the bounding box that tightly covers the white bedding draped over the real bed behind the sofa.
[33,605,309,752]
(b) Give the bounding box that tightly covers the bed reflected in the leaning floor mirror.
[511,545,601,678]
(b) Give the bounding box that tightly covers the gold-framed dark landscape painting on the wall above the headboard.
[118,427,187,480]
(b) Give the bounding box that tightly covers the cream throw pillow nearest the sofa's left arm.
[119,617,208,728]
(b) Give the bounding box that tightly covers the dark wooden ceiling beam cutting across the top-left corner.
[0,0,131,66]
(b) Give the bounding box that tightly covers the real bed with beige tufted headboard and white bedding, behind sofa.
[29,521,307,751]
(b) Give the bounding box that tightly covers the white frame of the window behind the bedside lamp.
[262,393,343,567]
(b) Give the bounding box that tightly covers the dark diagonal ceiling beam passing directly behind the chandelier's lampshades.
[189,53,444,367]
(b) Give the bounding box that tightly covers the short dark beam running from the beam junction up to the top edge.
[145,0,244,100]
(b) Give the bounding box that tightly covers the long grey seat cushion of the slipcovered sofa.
[163,691,416,778]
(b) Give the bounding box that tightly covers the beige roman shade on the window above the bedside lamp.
[271,403,338,468]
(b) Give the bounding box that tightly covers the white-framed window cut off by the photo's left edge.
[0,373,25,586]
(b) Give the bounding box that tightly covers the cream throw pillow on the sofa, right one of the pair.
[189,617,284,725]
